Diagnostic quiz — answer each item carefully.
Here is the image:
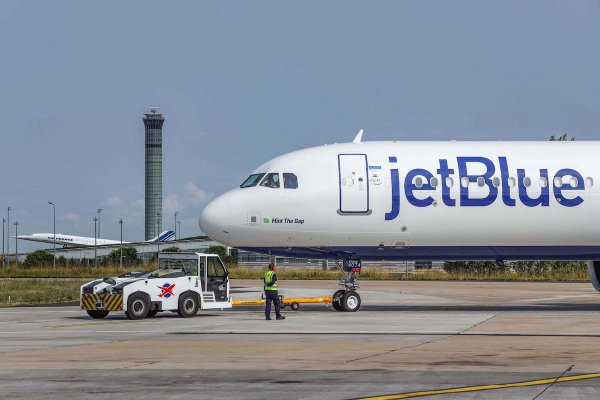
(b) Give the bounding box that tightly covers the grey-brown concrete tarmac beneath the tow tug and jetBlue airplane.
[0,281,600,400]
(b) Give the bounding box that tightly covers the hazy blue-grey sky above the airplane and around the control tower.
[0,0,600,250]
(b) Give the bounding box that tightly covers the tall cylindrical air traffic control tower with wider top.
[143,107,165,240]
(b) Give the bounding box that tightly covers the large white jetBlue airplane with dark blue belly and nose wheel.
[200,131,600,311]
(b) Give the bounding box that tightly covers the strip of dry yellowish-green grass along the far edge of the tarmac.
[0,265,589,307]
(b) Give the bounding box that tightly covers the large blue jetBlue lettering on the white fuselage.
[385,156,585,221]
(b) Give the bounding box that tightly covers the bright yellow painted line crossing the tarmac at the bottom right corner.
[358,373,600,400]
